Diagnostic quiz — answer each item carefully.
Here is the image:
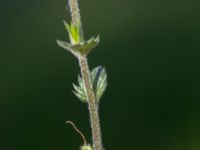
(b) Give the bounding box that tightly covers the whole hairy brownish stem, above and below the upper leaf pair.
[69,0,103,150]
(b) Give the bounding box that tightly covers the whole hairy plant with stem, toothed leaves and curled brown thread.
[57,0,107,150]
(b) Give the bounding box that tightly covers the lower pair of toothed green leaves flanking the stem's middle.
[73,66,107,102]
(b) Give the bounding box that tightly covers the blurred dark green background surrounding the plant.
[0,0,200,150]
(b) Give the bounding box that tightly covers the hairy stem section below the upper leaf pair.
[78,56,103,150]
